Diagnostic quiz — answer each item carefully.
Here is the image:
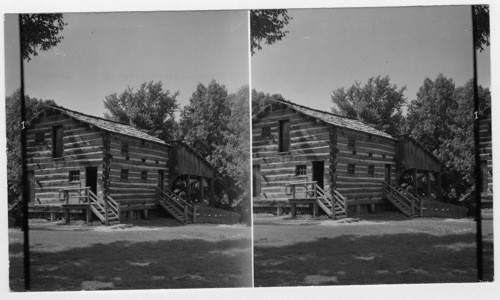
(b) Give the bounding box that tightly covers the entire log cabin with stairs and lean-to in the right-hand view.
[252,100,441,218]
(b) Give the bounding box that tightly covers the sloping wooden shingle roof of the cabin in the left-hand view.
[49,105,167,145]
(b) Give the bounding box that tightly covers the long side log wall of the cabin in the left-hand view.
[109,133,169,209]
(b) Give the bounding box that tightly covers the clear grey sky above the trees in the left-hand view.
[1,11,249,116]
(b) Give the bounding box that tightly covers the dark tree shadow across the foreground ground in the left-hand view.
[9,239,252,291]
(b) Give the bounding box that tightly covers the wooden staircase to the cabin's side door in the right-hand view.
[384,183,421,218]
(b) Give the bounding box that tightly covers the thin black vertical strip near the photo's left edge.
[19,14,30,291]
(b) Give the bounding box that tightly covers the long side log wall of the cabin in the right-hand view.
[335,128,396,206]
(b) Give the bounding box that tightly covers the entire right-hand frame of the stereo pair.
[250,5,494,287]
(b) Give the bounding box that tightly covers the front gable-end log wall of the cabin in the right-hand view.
[252,108,330,206]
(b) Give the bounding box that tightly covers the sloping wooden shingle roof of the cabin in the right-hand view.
[254,99,394,140]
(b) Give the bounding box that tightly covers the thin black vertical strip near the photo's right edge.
[471,5,483,281]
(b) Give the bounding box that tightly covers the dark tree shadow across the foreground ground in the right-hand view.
[254,233,482,287]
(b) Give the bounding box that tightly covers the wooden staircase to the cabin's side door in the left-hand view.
[156,189,193,224]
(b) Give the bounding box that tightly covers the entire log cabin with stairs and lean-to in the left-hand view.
[26,106,214,224]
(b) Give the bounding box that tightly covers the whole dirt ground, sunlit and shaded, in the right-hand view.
[254,214,493,287]
